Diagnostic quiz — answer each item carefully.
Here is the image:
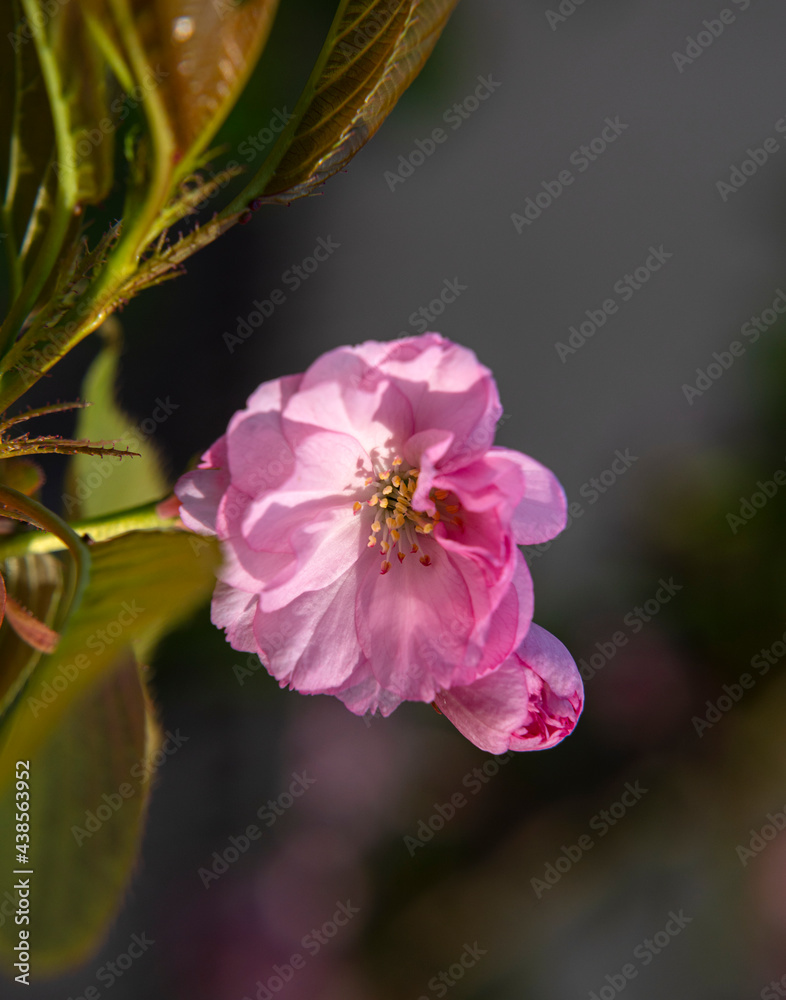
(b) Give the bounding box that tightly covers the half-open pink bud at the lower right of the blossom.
[435,624,584,754]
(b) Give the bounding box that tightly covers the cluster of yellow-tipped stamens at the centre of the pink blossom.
[354,455,461,574]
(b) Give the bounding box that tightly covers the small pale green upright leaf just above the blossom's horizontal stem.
[63,337,168,520]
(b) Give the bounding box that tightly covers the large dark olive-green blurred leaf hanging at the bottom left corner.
[0,648,160,978]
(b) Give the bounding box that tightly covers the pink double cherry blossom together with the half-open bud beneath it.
[176,333,581,752]
